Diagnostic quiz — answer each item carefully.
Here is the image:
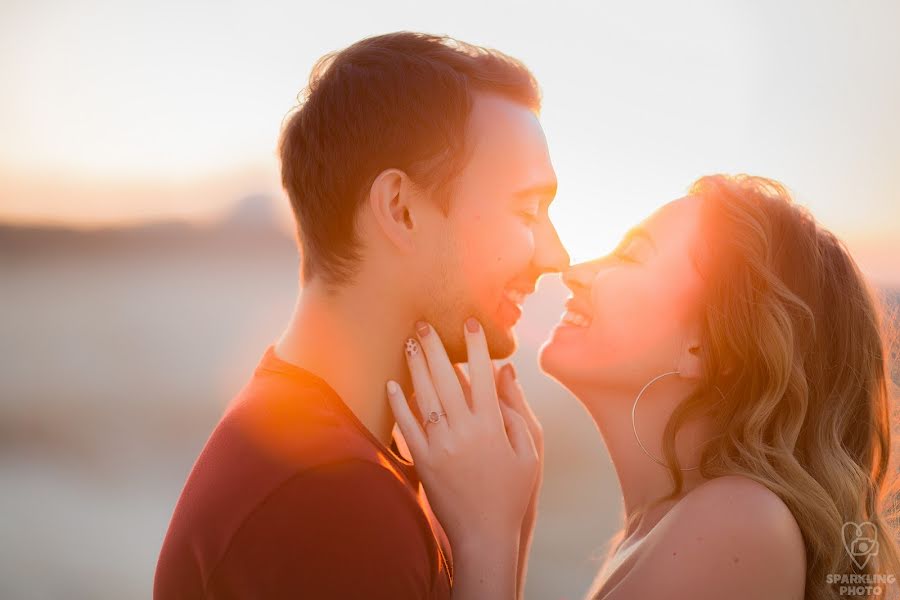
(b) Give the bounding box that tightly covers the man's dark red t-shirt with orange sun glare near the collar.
[153,346,451,600]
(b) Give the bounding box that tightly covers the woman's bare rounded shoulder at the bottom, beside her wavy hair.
[608,475,806,599]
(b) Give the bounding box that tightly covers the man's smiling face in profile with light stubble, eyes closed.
[420,95,569,362]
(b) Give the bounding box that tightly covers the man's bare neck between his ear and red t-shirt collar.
[275,280,413,446]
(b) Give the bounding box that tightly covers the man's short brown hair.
[278,32,540,285]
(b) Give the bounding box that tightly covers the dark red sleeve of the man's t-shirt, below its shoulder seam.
[199,460,449,598]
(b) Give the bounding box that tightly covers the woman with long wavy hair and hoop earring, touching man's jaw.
[388,175,900,599]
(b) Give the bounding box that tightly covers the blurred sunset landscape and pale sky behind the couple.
[0,0,900,600]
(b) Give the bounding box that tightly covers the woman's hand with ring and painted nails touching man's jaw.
[388,319,540,598]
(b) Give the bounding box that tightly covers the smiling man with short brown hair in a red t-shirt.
[154,33,568,599]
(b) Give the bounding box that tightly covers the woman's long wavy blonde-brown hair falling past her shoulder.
[620,175,900,600]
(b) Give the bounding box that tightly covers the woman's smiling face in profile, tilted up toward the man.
[540,196,703,393]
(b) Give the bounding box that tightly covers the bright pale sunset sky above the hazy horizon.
[0,0,900,284]
